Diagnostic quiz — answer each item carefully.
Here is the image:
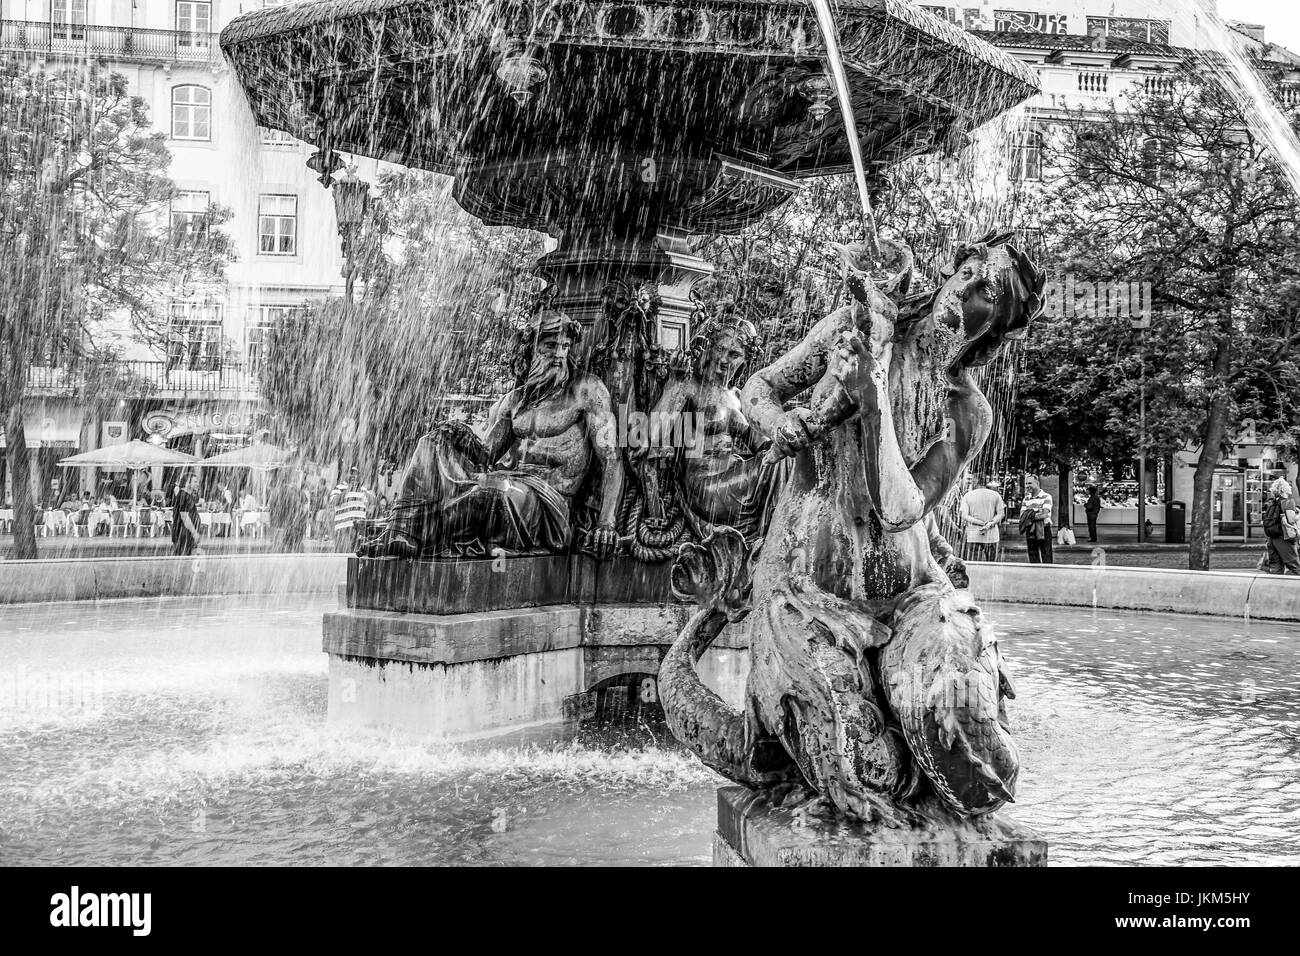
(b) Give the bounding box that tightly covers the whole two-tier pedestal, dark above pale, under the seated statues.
[324,555,749,739]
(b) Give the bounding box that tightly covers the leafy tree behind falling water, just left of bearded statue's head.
[263,170,545,476]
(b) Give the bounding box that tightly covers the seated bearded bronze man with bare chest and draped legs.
[359,310,623,558]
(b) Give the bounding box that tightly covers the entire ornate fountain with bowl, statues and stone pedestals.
[221,0,1045,865]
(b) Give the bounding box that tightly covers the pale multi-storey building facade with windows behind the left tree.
[0,0,342,499]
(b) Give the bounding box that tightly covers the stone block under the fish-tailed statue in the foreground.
[714,787,1048,866]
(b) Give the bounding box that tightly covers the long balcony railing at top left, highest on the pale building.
[0,20,221,64]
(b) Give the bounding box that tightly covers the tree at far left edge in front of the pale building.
[0,61,230,558]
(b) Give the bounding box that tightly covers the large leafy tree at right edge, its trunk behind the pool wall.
[1022,75,1300,570]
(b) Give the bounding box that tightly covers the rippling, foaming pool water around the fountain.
[0,597,1300,865]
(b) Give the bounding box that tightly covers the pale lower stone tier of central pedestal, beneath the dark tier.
[322,604,749,740]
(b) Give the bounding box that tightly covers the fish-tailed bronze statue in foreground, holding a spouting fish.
[660,235,1044,825]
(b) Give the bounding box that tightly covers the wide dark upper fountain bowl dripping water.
[221,0,1037,233]
